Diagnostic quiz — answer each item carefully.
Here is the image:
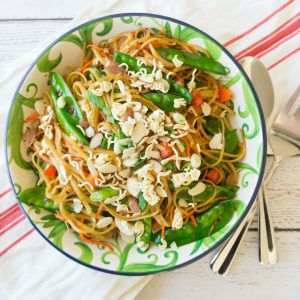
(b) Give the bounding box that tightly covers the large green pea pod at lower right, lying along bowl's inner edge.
[151,200,240,246]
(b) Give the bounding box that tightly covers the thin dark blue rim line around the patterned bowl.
[4,12,267,276]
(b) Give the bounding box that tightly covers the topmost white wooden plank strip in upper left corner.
[0,0,94,19]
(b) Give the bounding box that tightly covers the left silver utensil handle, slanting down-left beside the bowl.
[210,200,257,276]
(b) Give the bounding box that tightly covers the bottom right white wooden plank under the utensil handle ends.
[136,232,300,300]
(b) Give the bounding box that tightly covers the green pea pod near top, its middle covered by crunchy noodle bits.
[115,51,193,104]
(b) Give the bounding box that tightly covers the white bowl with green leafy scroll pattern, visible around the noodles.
[7,13,266,275]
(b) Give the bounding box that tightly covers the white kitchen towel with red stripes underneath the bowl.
[0,0,300,300]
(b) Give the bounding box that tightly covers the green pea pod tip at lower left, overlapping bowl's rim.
[18,187,58,211]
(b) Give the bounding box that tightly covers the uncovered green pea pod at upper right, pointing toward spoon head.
[156,49,230,75]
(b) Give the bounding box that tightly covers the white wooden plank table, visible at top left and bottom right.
[0,0,300,300]
